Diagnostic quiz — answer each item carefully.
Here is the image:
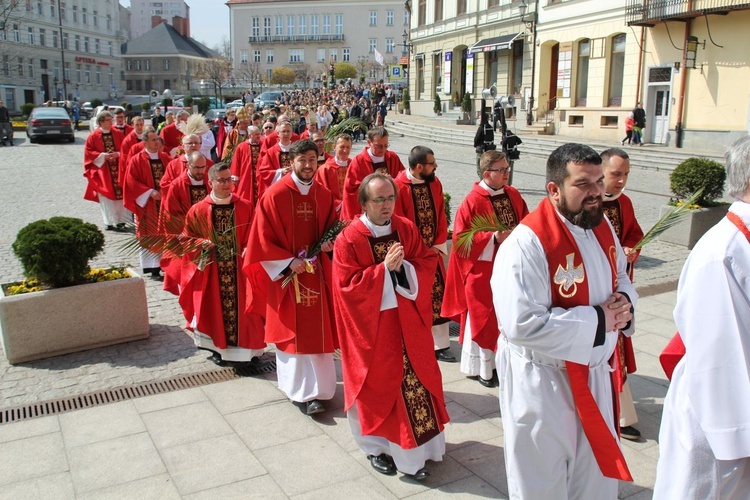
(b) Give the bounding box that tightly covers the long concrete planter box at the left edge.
[0,269,149,364]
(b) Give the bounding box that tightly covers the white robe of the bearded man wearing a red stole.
[490,214,637,500]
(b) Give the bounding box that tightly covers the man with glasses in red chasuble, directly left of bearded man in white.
[442,151,529,387]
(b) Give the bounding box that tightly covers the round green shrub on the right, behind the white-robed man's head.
[669,158,727,207]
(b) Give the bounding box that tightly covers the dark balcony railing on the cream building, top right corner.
[625,0,750,26]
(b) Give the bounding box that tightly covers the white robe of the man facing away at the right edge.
[654,202,750,499]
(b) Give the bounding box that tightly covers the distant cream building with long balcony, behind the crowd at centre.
[227,0,409,87]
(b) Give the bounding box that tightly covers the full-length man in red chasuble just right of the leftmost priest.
[123,127,171,278]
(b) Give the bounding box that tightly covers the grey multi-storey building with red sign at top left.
[0,0,125,111]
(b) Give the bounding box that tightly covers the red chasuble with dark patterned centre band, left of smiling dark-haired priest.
[180,195,266,349]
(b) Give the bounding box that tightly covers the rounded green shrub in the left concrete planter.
[12,217,104,288]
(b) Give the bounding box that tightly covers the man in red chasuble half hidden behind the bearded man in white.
[601,148,643,440]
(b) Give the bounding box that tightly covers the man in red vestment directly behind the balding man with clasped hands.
[341,127,404,220]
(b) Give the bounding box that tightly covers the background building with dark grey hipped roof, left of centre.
[122,23,218,95]
